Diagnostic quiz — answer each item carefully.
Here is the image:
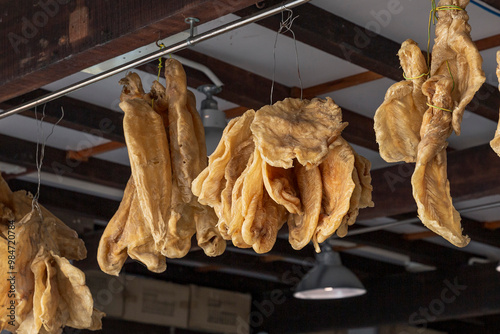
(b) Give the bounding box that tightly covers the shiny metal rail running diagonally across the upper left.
[0,0,310,119]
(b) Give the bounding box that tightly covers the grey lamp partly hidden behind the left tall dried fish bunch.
[198,84,227,155]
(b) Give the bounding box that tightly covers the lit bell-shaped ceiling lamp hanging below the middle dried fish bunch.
[293,243,366,299]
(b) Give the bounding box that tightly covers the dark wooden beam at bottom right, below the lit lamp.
[251,265,500,333]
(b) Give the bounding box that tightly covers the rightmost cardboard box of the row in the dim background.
[189,285,252,334]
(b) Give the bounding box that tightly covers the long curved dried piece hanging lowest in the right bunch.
[411,75,470,247]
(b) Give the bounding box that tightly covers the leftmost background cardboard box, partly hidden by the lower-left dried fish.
[85,270,125,318]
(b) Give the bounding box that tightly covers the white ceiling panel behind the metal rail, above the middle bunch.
[193,14,365,89]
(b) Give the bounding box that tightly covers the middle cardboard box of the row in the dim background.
[123,277,189,328]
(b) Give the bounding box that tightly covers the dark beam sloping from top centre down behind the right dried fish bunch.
[235,0,500,122]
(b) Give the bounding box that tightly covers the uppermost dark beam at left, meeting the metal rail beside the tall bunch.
[0,89,125,143]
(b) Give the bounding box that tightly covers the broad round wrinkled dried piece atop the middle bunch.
[251,97,347,168]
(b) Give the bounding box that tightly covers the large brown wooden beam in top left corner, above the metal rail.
[0,0,255,101]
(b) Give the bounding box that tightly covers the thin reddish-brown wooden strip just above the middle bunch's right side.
[292,71,384,99]
